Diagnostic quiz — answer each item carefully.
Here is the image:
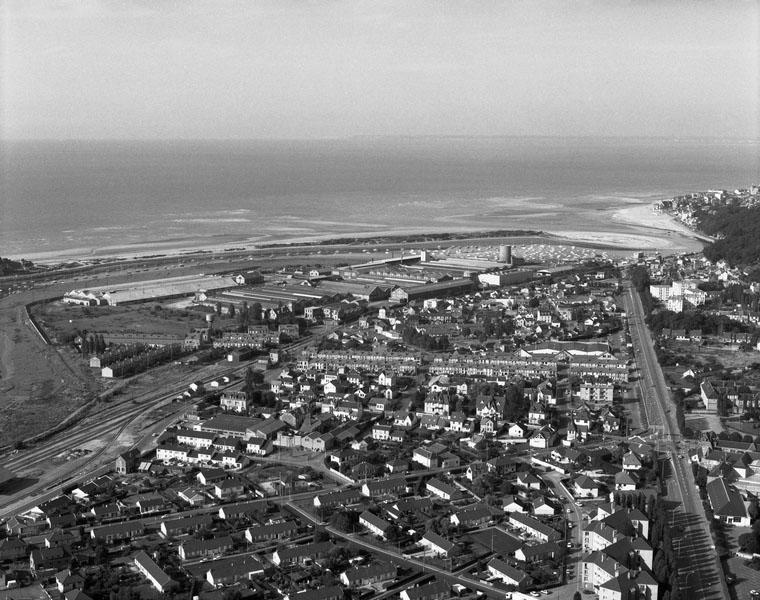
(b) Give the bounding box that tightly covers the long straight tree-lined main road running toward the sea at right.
[624,282,728,600]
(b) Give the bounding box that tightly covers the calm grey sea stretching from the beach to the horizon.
[0,137,760,259]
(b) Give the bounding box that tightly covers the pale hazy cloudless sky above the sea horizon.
[0,0,760,139]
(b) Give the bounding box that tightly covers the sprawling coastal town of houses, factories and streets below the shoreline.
[0,188,760,600]
